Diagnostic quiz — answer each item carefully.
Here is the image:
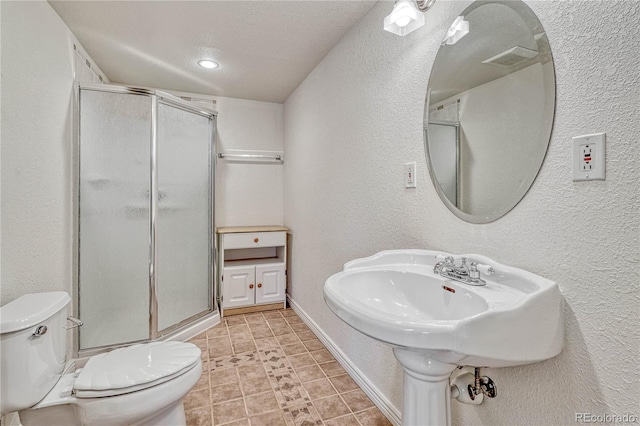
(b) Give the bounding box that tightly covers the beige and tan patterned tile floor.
[184,309,391,426]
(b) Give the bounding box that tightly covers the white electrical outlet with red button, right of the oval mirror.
[573,133,606,182]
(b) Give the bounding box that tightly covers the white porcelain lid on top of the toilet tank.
[0,291,71,334]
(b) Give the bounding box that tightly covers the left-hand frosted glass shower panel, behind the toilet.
[78,90,151,349]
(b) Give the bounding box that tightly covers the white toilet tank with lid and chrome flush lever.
[0,291,70,415]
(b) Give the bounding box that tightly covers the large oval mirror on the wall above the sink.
[424,1,555,223]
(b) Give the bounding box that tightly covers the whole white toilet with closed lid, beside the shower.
[0,292,202,426]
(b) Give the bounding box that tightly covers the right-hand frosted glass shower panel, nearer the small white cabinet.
[156,102,213,332]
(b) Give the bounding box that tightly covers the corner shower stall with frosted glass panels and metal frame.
[74,83,219,356]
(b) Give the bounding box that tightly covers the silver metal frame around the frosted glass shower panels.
[72,81,218,358]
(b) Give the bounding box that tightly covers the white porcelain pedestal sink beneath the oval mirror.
[324,250,564,426]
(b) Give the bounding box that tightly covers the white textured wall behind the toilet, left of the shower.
[1,1,75,304]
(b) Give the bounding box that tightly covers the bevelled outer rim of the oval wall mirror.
[422,0,557,224]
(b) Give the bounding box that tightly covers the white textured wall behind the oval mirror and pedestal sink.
[284,1,640,425]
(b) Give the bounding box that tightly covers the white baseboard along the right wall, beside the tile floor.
[287,296,402,426]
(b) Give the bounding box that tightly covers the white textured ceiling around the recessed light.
[50,0,382,102]
